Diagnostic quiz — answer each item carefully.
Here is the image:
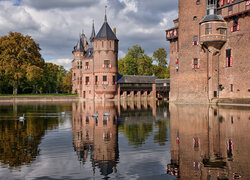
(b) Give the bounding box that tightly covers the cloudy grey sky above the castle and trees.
[0,0,178,69]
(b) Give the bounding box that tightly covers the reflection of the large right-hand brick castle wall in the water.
[168,104,250,180]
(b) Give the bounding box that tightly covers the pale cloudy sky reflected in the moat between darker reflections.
[0,104,173,179]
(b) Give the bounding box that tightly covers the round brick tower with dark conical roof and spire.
[93,8,119,99]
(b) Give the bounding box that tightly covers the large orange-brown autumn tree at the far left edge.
[0,32,44,95]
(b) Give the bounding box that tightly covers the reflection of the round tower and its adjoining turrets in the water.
[72,102,119,176]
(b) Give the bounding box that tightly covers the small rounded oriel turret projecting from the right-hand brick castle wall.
[200,0,227,49]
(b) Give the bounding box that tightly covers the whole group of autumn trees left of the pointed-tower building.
[0,32,71,95]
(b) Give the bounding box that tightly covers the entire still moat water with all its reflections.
[0,101,250,180]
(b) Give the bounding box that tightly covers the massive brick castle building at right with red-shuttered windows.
[166,0,250,103]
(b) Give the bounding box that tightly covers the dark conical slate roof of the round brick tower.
[95,22,118,40]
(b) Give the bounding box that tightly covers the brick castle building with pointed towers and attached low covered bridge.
[72,13,169,100]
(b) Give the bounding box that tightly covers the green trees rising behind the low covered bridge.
[118,45,170,79]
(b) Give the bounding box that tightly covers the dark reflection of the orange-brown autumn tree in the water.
[0,114,58,167]
